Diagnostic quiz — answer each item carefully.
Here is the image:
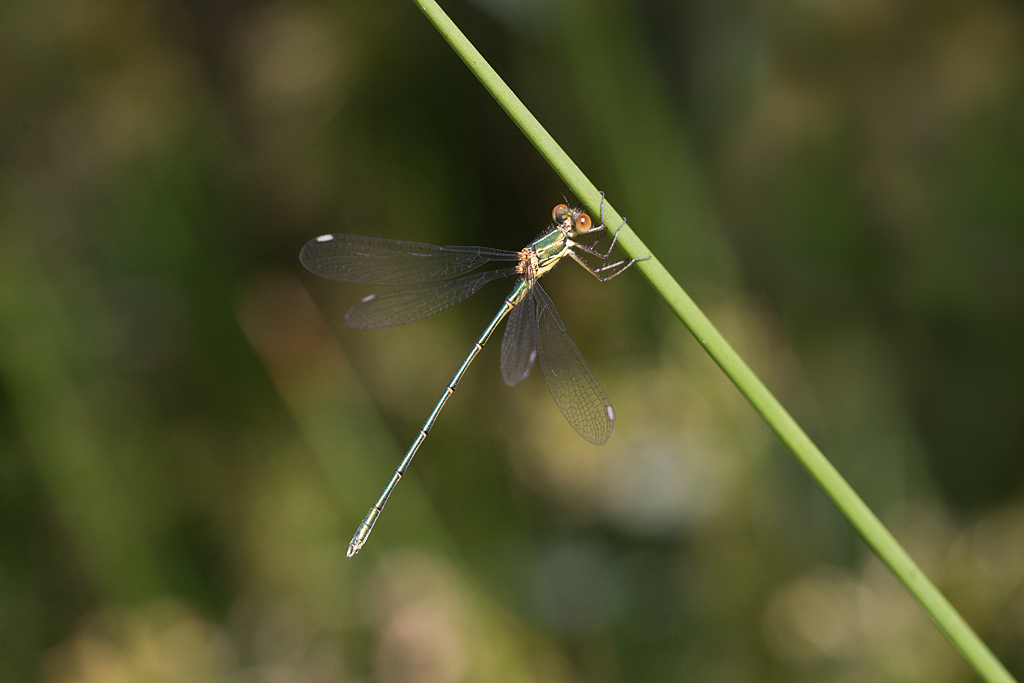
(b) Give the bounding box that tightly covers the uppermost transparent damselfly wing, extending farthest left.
[299,234,519,287]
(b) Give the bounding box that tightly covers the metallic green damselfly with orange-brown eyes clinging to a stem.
[300,198,649,557]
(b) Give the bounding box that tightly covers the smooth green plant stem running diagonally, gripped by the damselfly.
[415,0,1014,683]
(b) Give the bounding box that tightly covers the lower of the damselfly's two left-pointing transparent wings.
[345,268,516,330]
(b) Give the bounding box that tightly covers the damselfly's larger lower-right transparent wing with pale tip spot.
[532,284,615,443]
